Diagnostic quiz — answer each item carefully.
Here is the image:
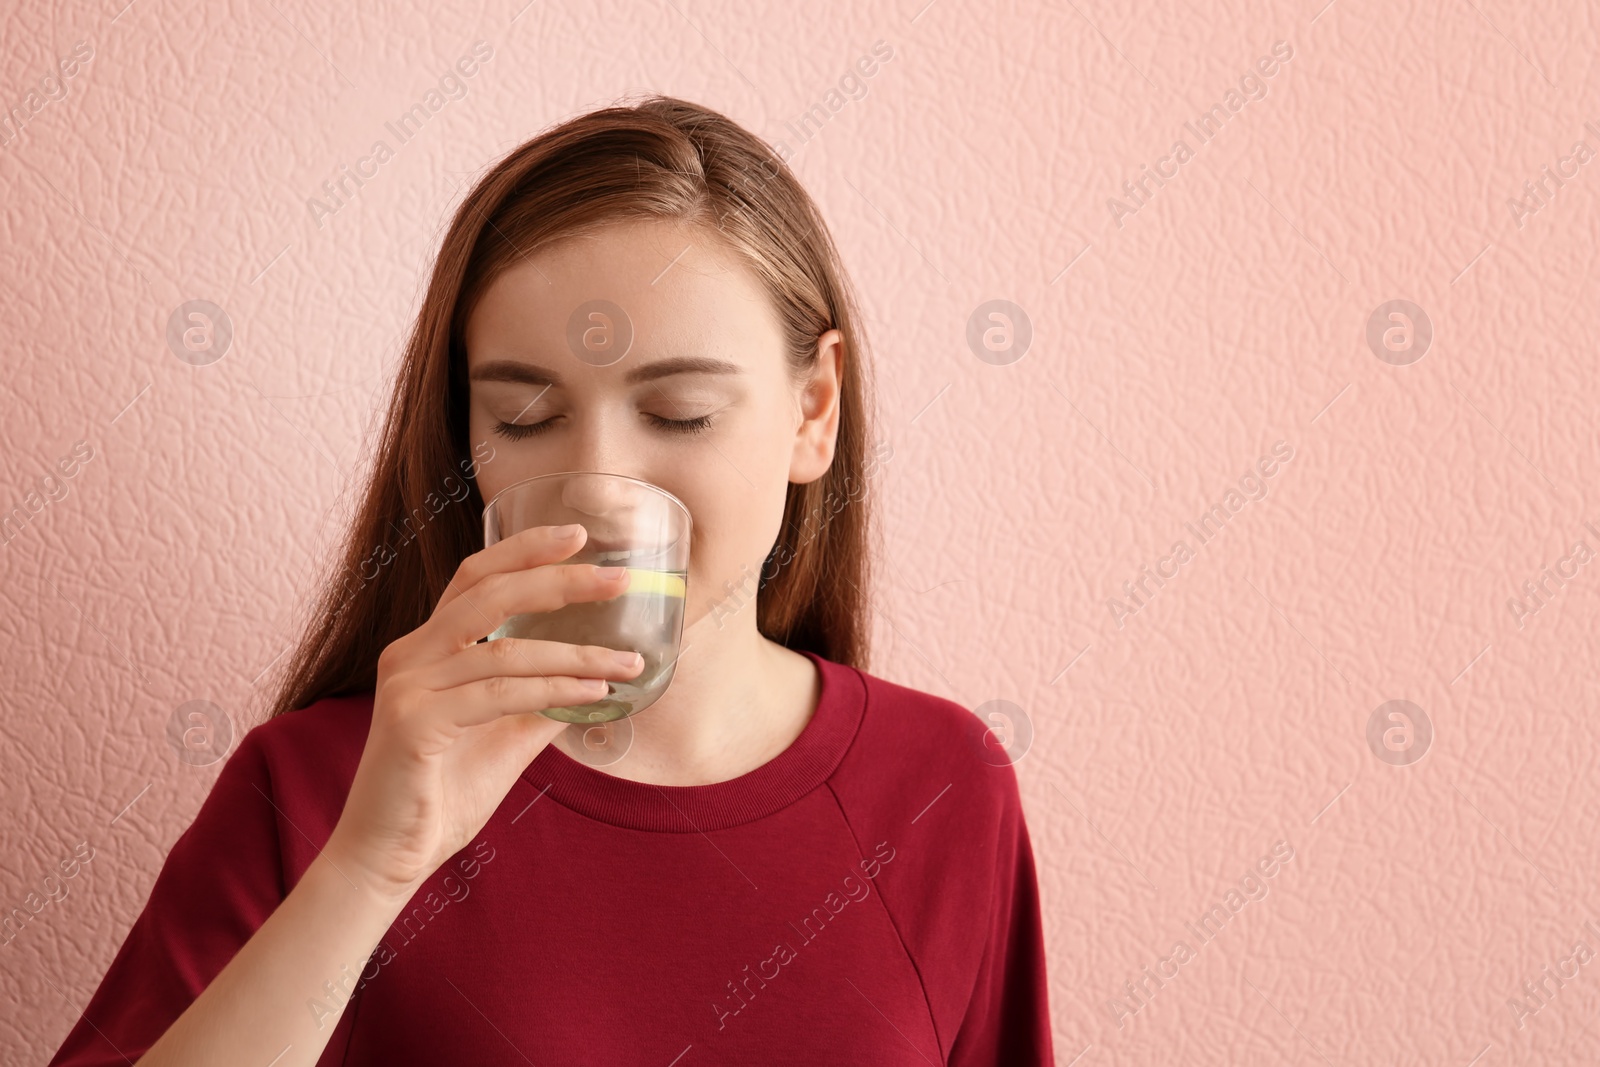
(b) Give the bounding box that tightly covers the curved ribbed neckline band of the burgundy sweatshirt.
[522,649,867,833]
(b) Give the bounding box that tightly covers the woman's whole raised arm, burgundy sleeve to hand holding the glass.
[53,526,643,1067]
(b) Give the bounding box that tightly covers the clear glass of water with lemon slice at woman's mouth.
[483,470,691,723]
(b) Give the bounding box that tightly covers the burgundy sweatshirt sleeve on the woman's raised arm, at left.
[50,726,352,1067]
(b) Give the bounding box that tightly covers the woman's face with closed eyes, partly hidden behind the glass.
[466,221,843,629]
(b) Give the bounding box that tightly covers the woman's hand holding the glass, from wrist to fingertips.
[326,526,643,902]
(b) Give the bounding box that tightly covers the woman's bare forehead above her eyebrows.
[466,221,782,368]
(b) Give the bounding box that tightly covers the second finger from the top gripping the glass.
[428,563,629,656]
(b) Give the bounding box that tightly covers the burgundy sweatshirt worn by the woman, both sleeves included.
[51,653,1053,1067]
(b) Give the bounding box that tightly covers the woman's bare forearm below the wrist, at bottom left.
[139,851,406,1067]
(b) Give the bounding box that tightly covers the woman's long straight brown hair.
[269,96,893,718]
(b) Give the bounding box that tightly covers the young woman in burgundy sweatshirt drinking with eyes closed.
[53,98,1053,1067]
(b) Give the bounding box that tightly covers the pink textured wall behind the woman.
[0,0,1600,1065]
